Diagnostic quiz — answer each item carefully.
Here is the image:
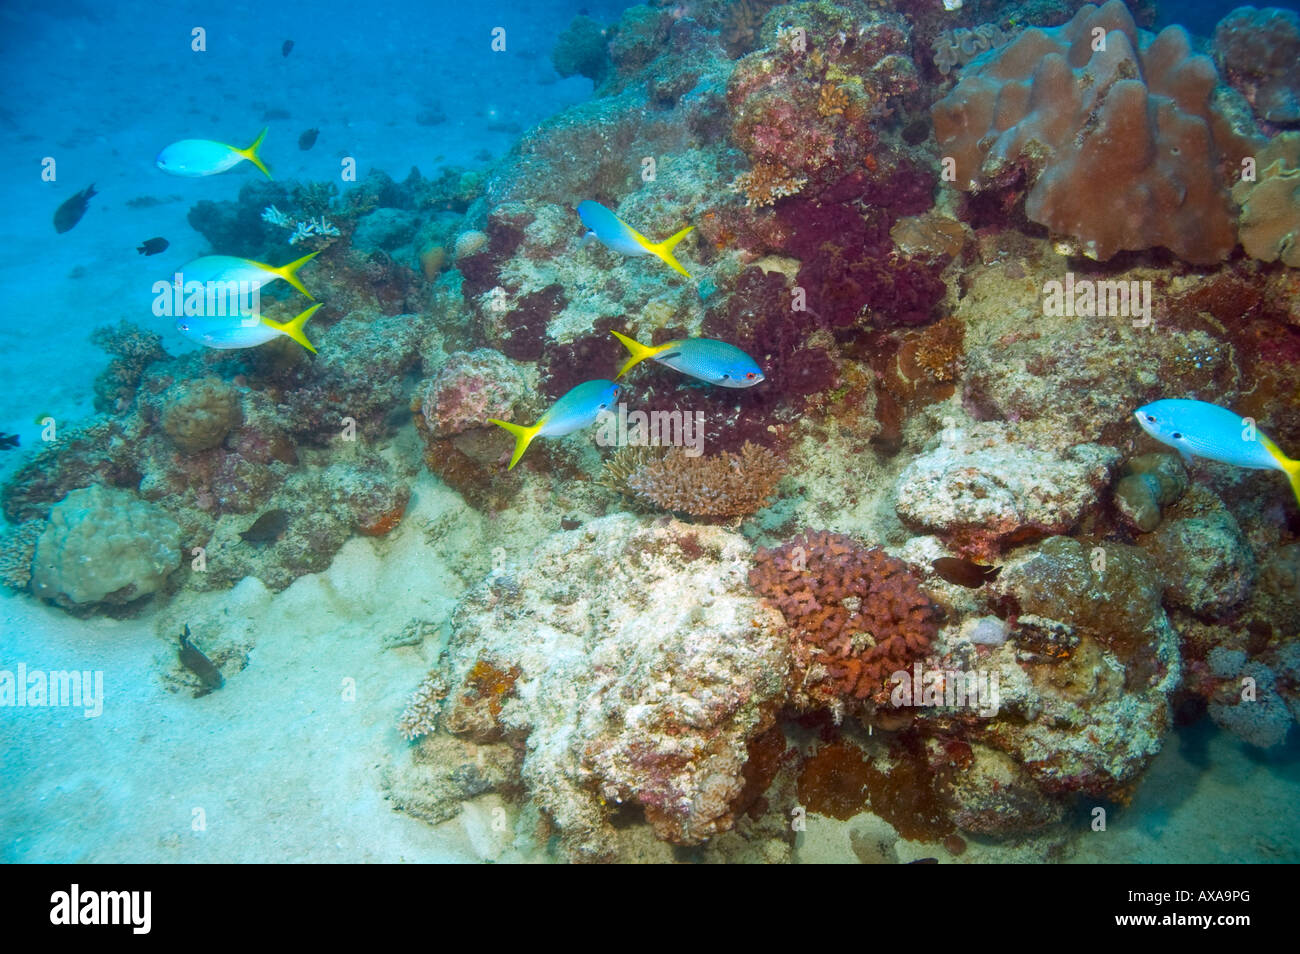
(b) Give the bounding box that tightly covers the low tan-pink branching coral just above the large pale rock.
[605,442,785,517]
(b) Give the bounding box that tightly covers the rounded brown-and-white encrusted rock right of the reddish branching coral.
[970,537,1182,799]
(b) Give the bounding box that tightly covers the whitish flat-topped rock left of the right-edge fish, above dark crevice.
[896,424,1119,558]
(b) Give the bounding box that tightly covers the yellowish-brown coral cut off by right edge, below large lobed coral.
[1232,133,1300,268]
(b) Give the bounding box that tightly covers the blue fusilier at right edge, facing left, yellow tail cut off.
[1134,399,1300,503]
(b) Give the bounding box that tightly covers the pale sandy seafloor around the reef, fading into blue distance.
[0,1,1300,862]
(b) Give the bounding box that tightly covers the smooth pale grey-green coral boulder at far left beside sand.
[31,483,181,607]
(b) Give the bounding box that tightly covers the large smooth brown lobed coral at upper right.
[932,0,1249,264]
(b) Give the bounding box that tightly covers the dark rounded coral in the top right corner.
[1214,6,1300,123]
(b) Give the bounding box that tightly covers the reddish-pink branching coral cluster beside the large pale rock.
[749,530,937,711]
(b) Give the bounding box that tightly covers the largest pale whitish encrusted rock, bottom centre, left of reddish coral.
[431,515,790,859]
